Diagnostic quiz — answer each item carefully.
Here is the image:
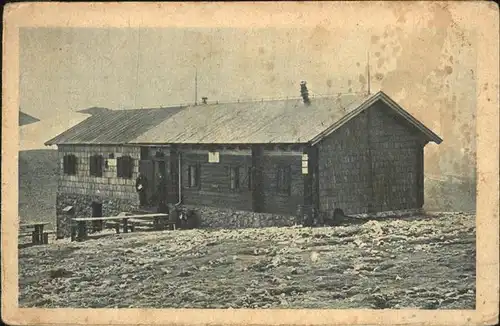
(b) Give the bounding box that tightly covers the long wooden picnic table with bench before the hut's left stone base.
[71,212,171,241]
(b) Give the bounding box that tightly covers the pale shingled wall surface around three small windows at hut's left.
[58,145,140,200]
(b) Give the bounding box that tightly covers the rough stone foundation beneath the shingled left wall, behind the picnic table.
[56,194,138,238]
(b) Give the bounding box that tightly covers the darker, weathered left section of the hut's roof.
[45,107,181,145]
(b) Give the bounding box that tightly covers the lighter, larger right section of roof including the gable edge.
[130,92,442,144]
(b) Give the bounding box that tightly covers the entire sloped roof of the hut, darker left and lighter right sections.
[45,92,442,145]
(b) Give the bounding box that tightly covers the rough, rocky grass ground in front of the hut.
[19,213,475,309]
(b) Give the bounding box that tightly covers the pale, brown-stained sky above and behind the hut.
[19,3,478,210]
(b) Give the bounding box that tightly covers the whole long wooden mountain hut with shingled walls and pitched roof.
[47,92,442,237]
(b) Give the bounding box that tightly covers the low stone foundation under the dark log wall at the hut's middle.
[186,205,302,229]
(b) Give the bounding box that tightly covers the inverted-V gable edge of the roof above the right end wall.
[310,91,443,146]
